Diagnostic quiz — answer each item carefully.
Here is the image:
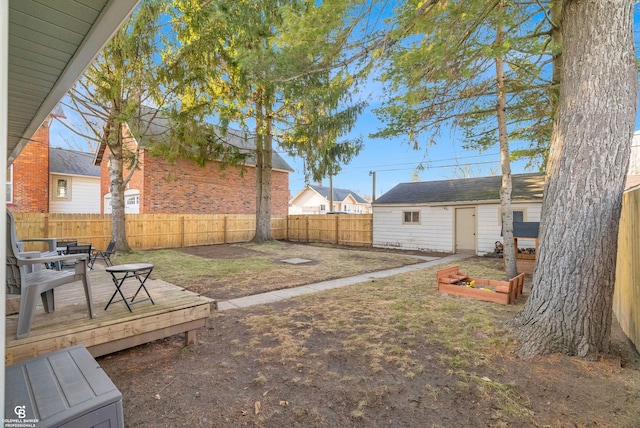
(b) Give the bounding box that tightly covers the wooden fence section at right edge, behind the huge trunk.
[613,189,640,349]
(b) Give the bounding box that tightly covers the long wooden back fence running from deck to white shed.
[14,213,373,250]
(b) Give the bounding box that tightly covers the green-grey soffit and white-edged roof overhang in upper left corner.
[7,0,139,164]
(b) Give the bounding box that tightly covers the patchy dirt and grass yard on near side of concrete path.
[99,249,640,428]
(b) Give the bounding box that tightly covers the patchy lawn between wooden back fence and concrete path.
[117,242,424,301]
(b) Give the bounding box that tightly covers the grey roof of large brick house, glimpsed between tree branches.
[94,106,293,172]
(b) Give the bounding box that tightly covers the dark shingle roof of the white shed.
[373,174,544,205]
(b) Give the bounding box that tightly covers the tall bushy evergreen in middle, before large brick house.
[162,0,363,242]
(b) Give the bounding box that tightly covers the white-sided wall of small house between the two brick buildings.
[49,174,100,214]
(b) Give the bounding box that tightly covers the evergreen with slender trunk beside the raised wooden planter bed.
[374,0,553,278]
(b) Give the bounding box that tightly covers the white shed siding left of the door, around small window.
[373,206,453,253]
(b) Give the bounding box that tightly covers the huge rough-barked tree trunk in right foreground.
[514,0,637,358]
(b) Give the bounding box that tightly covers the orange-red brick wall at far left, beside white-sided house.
[7,120,50,213]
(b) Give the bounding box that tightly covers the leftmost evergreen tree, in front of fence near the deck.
[63,0,170,252]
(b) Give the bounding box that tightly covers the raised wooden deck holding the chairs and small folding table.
[5,270,215,366]
